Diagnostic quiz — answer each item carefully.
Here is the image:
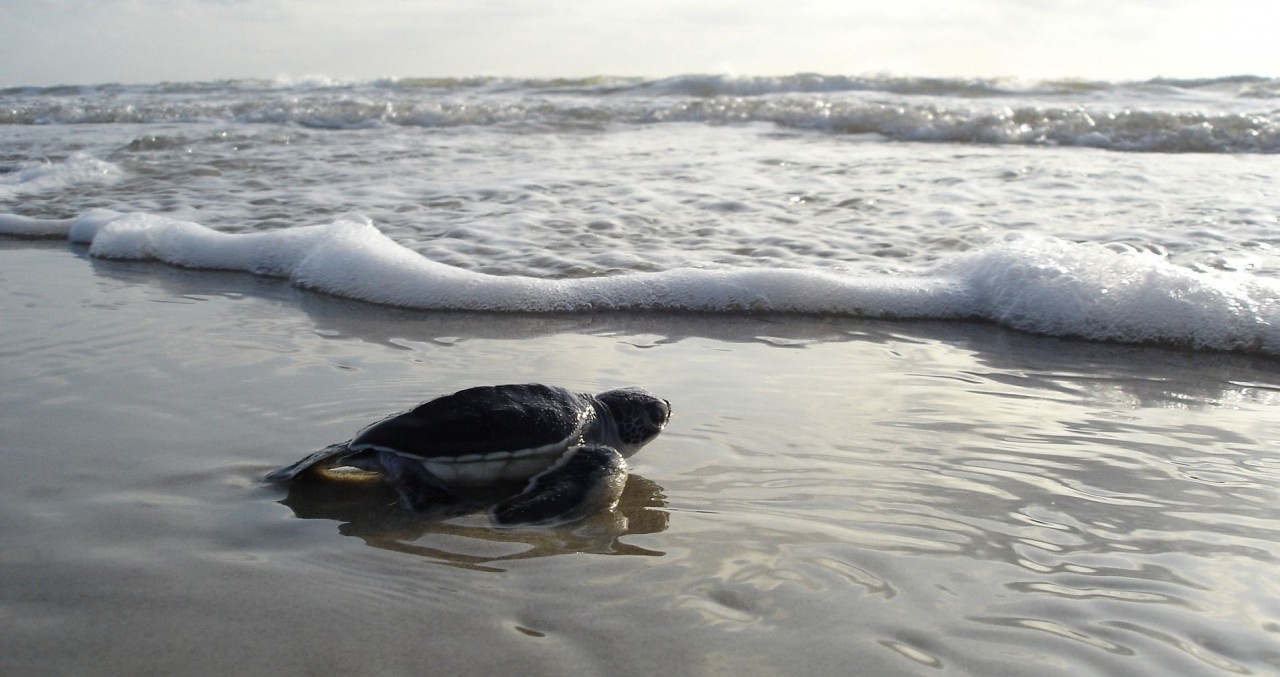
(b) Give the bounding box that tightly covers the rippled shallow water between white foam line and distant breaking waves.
[0,123,1280,276]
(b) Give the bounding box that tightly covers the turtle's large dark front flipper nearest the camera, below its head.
[489,444,627,526]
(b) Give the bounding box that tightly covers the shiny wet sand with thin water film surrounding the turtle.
[0,243,1280,676]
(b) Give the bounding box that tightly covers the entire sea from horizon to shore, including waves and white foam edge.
[0,76,1280,357]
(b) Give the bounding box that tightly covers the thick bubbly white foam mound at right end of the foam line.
[940,237,1280,354]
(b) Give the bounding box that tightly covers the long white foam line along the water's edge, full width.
[0,210,1280,356]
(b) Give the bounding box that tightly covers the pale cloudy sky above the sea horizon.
[0,0,1280,87]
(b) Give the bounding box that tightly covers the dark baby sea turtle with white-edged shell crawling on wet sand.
[265,384,671,525]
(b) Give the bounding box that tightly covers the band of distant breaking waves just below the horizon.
[0,74,1280,154]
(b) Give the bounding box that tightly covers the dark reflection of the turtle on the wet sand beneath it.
[280,474,669,571]
